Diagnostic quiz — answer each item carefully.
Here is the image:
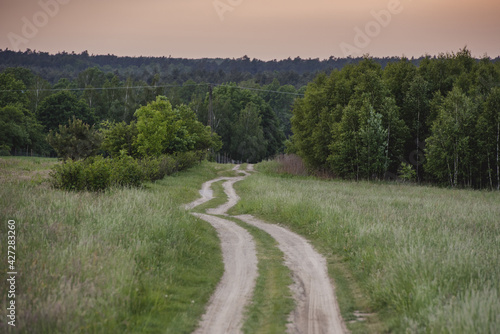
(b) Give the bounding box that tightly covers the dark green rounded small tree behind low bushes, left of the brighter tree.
[47,116,101,160]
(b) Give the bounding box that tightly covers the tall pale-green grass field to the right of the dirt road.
[235,161,500,333]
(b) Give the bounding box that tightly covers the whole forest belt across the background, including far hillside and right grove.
[0,48,500,189]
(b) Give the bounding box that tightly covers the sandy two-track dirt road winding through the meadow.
[186,165,347,334]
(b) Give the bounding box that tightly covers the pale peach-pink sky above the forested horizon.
[0,0,500,60]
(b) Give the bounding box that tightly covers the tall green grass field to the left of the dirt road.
[0,158,229,333]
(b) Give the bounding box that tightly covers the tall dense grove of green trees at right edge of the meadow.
[289,48,500,189]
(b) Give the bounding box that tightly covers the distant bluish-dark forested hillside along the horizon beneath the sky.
[0,49,422,88]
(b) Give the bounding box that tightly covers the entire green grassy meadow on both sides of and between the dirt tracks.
[0,158,500,333]
